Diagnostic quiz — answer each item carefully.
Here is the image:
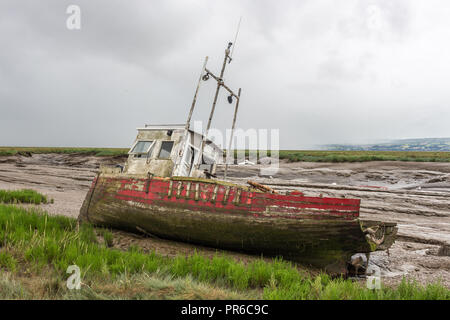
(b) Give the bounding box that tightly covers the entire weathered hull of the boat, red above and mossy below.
[79,174,396,273]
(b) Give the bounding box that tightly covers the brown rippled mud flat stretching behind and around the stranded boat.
[0,154,450,288]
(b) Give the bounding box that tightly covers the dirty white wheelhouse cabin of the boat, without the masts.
[123,124,223,178]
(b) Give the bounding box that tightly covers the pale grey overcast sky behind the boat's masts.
[0,0,450,149]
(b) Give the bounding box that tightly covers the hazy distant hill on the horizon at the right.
[322,138,450,152]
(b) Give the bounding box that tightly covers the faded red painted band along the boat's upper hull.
[89,178,360,219]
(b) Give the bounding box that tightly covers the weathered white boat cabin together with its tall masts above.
[100,42,241,179]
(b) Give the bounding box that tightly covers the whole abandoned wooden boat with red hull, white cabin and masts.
[79,41,397,273]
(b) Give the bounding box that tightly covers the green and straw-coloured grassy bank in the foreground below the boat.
[0,205,450,299]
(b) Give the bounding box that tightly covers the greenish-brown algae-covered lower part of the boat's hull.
[80,175,396,273]
